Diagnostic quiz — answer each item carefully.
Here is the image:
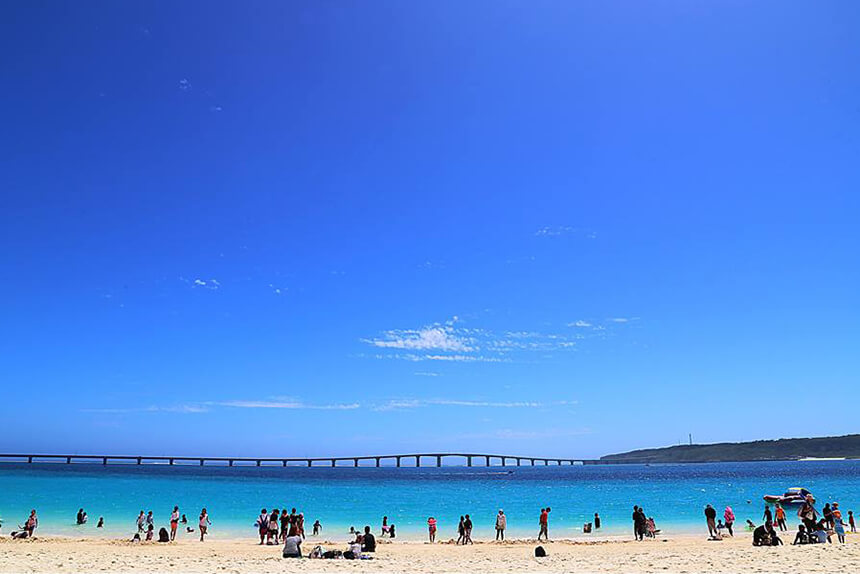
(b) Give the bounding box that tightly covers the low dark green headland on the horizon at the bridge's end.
[600,434,860,462]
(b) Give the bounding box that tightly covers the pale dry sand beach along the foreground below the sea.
[0,533,860,574]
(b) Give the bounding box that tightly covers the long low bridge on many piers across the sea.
[0,452,612,468]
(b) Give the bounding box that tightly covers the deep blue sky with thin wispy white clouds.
[0,1,860,457]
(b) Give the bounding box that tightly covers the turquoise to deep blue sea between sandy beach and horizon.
[0,461,860,540]
